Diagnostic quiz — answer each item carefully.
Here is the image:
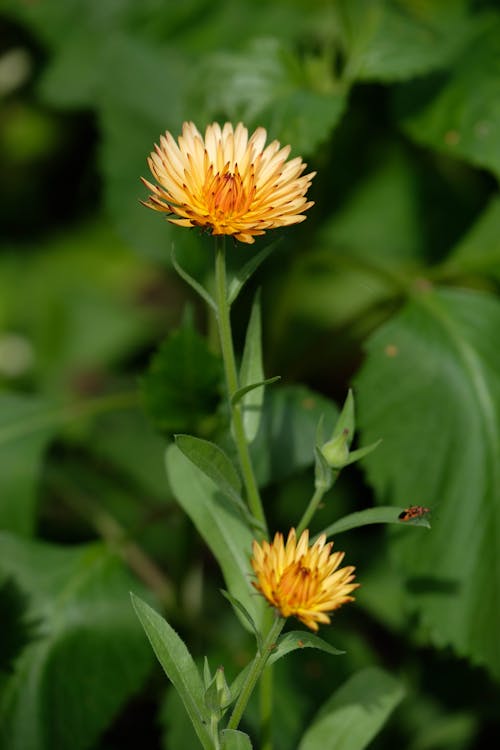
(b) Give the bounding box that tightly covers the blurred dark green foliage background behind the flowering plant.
[0,0,500,750]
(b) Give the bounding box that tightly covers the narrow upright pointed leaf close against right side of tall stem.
[239,293,264,443]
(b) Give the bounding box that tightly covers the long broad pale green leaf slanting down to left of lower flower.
[166,446,264,627]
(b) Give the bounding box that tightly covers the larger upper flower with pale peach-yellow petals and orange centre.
[141,122,316,243]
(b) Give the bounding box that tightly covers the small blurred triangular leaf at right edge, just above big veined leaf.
[442,194,500,280]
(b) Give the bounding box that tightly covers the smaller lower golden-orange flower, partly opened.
[251,529,359,631]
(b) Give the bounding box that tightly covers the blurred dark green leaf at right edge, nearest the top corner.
[398,14,500,176]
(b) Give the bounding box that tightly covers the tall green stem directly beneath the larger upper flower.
[215,237,267,529]
